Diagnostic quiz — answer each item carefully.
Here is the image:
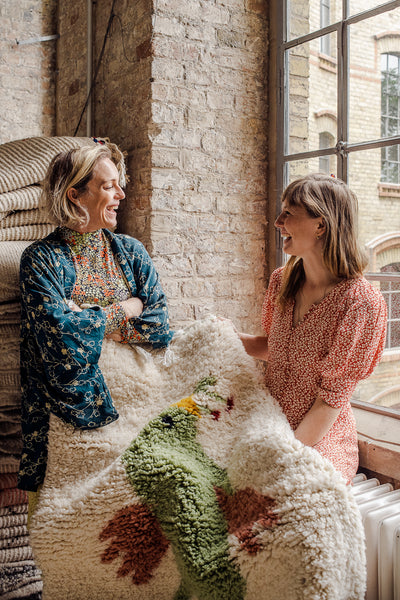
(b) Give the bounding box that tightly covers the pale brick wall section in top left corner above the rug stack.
[0,0,57,143]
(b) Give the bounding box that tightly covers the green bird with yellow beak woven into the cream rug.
[122,379,245,600]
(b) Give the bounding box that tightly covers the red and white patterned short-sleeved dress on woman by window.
[261,268,387,482]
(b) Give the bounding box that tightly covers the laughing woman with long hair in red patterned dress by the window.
[234,174,387,482]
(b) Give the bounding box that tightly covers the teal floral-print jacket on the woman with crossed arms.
[18,229,173,491]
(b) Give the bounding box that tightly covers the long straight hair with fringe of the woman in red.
[277,173,368,309]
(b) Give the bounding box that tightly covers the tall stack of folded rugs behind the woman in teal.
[0,137,94,600]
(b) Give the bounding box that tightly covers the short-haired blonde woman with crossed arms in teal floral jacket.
[19,144,172,492]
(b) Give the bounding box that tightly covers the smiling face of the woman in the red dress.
[275,200,325,257]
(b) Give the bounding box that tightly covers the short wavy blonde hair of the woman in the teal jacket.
[42,143,127,231]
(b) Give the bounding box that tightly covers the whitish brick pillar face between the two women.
[147,0,267,329]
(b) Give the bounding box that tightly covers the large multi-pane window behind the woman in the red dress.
[269,0,400,418]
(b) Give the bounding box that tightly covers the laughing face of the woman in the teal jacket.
[70,158,125,233]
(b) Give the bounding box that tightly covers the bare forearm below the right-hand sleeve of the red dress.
[295,398,340,446]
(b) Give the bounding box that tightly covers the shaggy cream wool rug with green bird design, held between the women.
[30,318,365,600]
